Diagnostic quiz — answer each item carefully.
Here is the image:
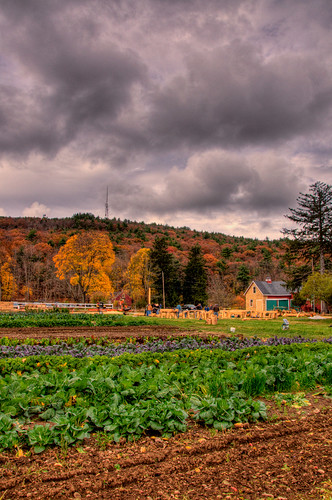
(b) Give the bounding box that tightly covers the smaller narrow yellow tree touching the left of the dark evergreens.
[126,248,152,304]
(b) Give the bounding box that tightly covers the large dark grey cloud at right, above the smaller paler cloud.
[151,46,332,146]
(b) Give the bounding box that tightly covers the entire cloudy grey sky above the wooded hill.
[0,0,332,238]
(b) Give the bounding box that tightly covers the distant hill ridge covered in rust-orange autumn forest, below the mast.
[0,213,286,261]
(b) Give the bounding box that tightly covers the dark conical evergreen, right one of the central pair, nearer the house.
[183,245,208,304]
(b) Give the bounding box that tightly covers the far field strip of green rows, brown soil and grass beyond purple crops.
[0,313,332,339]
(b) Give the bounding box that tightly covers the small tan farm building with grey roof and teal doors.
[244,278,292,311]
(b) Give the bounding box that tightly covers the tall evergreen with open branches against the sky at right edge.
[283,182,332,273]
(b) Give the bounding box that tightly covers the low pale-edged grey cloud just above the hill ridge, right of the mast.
[111,149,304,216]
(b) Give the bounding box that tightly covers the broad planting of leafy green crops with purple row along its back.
[0,338,332,452]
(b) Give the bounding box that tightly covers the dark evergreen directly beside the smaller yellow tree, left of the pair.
[150,236,181,307]
